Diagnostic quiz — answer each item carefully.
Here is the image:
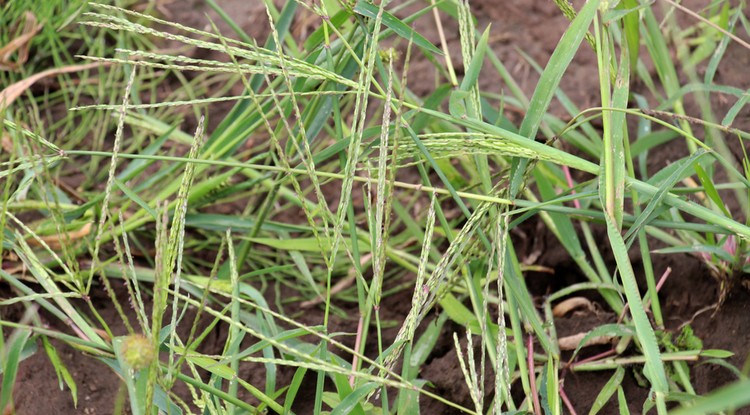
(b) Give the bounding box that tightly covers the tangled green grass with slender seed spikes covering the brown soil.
[0,0,750,414]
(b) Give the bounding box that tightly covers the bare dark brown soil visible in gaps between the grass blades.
[2,0,750,415]
